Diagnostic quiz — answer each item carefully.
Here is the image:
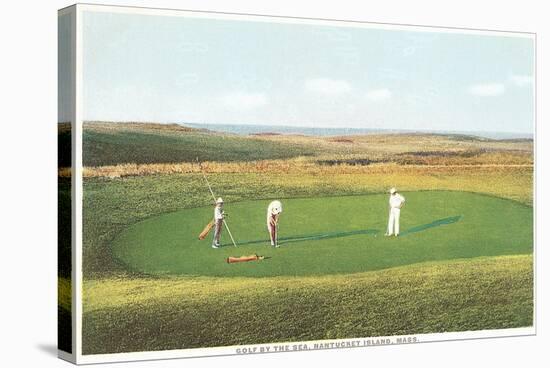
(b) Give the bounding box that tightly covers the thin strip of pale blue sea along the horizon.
[187,123,533,139]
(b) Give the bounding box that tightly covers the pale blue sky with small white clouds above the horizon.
[73,11,534,133]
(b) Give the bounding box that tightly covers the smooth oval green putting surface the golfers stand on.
[112,191,533,277]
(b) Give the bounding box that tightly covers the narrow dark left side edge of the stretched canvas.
[57,10,75,354]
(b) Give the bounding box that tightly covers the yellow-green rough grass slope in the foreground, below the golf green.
[83,255,533,354]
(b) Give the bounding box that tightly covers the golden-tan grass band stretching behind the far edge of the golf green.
[75,164,533,203]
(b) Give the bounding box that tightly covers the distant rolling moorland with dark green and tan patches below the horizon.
[75,122,533,167]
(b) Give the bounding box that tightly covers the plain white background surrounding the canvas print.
[0,0,550,368]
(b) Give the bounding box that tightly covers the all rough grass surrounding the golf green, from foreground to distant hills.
[80,124,533,354]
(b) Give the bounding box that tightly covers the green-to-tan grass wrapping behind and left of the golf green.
[83,168,532,279]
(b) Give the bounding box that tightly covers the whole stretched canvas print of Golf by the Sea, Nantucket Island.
[58,5,535,363]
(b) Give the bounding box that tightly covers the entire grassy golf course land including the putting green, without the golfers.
[77,128,533,354]
